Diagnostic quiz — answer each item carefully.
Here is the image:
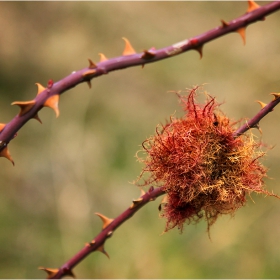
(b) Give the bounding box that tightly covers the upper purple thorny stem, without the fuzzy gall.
[0,1,280,156]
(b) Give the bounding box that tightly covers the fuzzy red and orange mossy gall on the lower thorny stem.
[136,87,279,233]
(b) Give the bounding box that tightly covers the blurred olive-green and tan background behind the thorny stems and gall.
[0,2,280,278]
